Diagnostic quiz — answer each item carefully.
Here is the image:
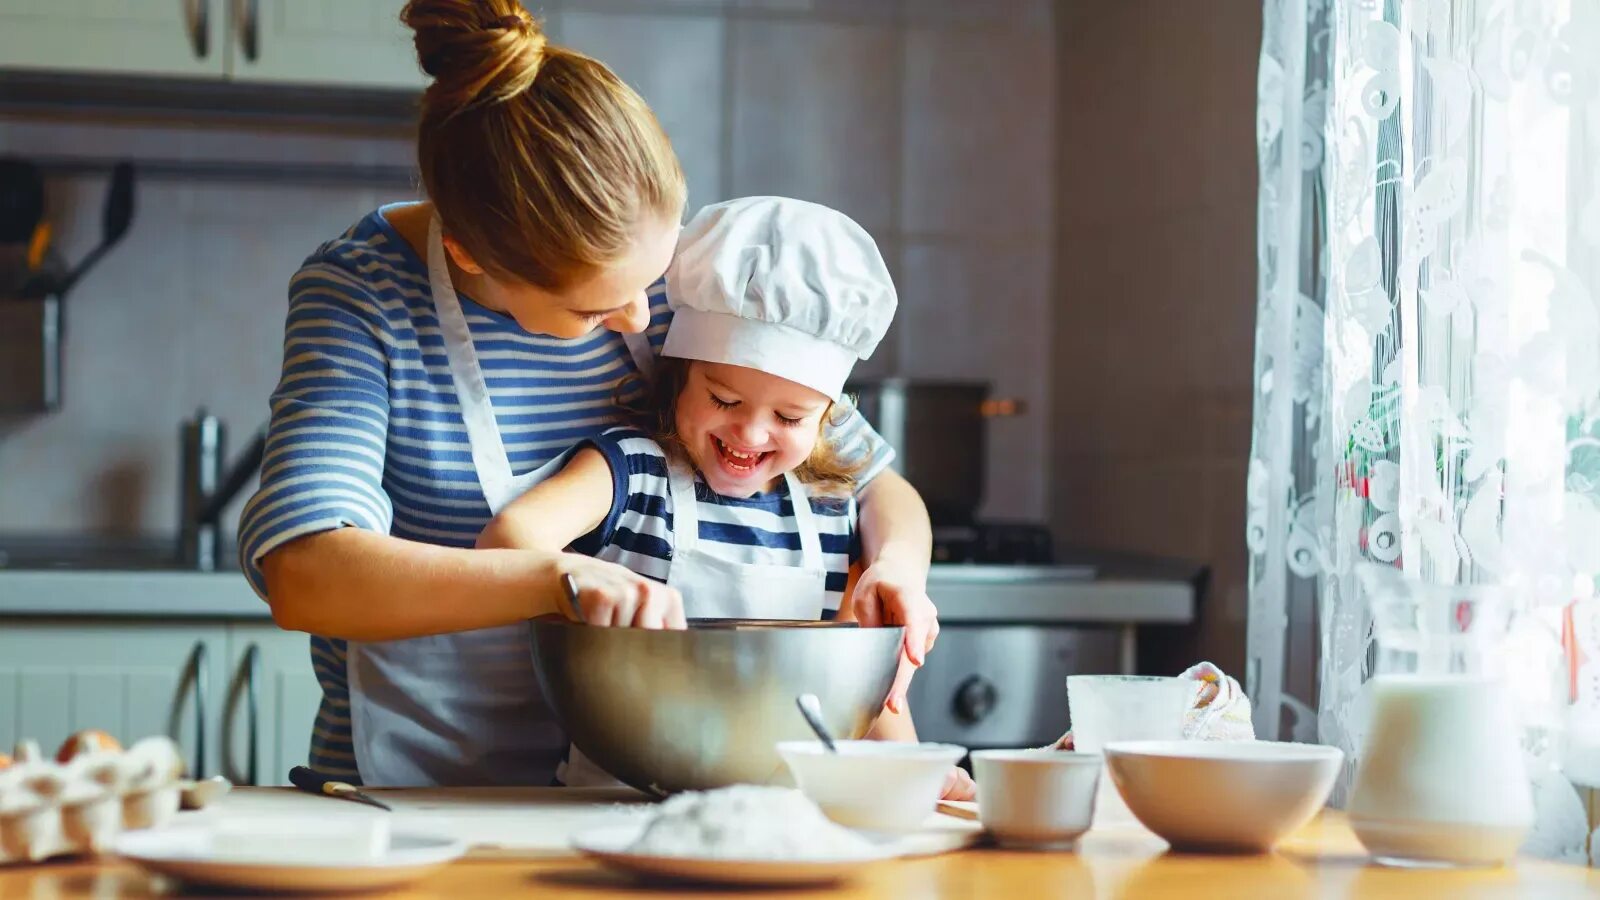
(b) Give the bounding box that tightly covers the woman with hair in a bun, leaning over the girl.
[240,0,938,785]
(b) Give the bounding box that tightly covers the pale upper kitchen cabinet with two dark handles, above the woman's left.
[0,0,424,90]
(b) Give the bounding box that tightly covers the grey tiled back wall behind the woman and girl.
[0,0,1059,536]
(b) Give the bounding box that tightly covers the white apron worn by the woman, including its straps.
[347,218,654,786]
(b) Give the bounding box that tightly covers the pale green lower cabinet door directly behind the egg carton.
[0,620,227,775]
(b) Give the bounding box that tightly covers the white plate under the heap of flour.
[573,825,886,887]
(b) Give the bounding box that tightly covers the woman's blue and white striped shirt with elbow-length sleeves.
[238,210,893,778]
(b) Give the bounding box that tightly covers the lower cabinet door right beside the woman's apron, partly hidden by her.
[222,621,322,785]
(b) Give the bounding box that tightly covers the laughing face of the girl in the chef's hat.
[677,360,832,496]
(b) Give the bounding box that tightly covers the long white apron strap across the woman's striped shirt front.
[427,215,515,512]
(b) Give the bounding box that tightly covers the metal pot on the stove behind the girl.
[845,378,1022,525]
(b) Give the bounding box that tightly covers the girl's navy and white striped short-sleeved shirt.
[573,428,861,608]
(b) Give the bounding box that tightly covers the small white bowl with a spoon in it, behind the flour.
[778,740,966,833]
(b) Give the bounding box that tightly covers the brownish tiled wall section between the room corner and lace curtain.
[1050,0,1261,673]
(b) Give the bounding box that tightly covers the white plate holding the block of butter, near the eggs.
[112,826,467,892]
